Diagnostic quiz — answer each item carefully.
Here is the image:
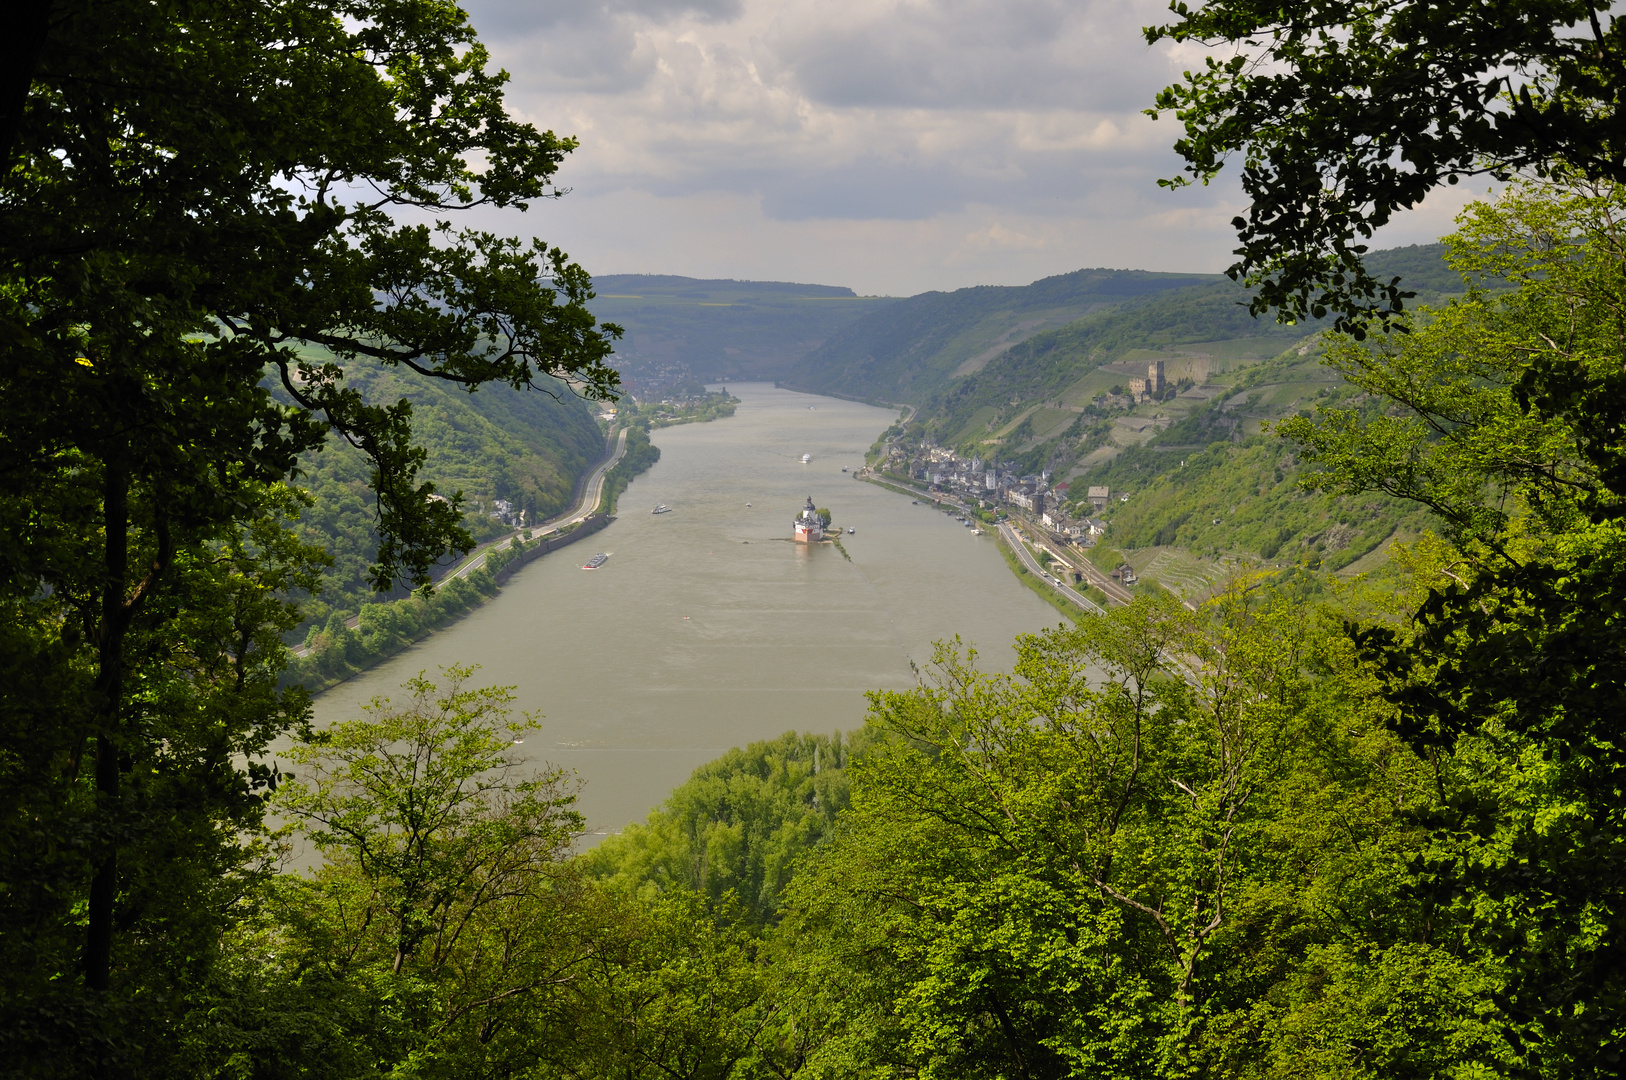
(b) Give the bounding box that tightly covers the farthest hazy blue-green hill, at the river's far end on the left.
[589,273,894,395]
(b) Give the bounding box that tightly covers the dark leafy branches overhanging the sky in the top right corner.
[1145,0,1626,337]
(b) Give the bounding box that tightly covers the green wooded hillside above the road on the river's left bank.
[282,349,605,636]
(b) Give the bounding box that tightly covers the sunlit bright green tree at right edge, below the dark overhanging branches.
[1281,185,1626,1077]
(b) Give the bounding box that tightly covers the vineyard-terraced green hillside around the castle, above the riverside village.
[871,244,1463,594]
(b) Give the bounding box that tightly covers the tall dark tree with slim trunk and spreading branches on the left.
[0,0,616,1044]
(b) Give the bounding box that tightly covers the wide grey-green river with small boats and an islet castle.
[315,384,1062,831]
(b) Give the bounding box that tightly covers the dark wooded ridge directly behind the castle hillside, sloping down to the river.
[784,270,1218,402]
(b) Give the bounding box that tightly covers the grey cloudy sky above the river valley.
[465,0,1489,296]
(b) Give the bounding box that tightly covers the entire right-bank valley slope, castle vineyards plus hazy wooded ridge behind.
[813,244,1465,595]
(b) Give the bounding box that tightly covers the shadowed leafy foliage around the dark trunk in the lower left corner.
[0,491,330,1077]
